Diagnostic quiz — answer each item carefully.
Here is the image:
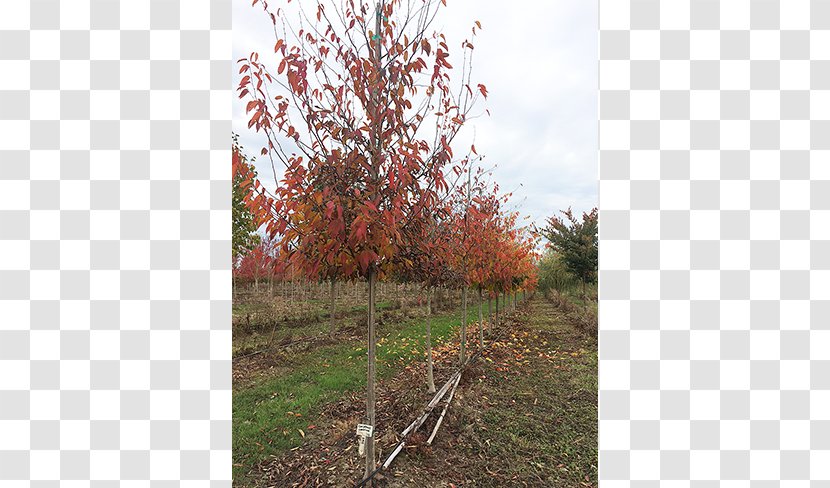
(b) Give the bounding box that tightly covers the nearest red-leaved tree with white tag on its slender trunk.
[238,0,487,475]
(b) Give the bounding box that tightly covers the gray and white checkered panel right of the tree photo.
[599,0,830,488]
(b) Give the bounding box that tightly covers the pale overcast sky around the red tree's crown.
[233,0,598,231]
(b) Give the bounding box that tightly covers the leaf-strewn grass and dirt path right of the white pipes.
[387,298,597,488]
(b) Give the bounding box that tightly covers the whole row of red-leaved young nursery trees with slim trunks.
[232,0,548,482]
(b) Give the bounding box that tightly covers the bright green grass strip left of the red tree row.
[233,302,472,483]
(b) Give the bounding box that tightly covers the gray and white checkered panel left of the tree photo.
[0,0,231,488]
